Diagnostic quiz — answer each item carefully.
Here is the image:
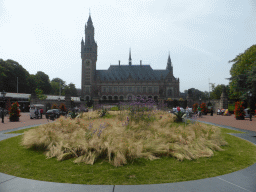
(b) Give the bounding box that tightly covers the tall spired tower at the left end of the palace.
[81,15,97,99]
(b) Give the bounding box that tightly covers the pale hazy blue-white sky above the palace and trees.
[0,0,256,92]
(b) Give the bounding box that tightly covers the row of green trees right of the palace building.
[185,45,256,110]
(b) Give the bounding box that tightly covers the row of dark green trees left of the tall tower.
[0,59,77,96]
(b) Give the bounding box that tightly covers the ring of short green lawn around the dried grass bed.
[0,124,256,185]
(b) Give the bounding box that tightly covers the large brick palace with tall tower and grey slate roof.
[81,16,180,105]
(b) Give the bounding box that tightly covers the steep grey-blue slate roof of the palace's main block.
[96,65,174,81]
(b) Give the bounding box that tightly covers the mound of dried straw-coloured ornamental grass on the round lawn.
[22,111,227,166]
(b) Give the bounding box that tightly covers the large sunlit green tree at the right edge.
[229,45,256,99]
